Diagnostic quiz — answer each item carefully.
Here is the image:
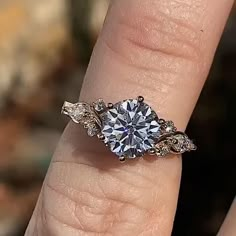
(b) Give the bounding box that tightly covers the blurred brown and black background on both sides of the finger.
[0,0,236,236]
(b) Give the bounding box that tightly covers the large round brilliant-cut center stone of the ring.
[102,99,160,158]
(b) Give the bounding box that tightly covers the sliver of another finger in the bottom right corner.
[218,200,236,236]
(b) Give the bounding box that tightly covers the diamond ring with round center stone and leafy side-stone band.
[62,96,196,161]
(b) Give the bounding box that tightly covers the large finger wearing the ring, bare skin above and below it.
[25,0,233,236]
